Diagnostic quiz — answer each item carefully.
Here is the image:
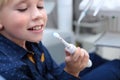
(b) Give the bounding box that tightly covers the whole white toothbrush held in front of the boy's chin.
[53,32,92,67]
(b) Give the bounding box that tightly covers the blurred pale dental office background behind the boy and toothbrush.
[42,0,120,64]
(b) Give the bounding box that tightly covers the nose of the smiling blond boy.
[31,8,43,20]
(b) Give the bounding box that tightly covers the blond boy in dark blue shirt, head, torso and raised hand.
[0,0,89,80]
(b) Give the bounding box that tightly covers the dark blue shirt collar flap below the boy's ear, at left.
[0,35,31,59]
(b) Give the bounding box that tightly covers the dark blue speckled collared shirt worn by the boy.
[0,35,79,80]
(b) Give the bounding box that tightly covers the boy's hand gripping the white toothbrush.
[64,47,89,77]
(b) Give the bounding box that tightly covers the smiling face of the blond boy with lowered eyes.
[0,0,47,42]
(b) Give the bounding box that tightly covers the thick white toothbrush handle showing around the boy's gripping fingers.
[65,44,92,67]
